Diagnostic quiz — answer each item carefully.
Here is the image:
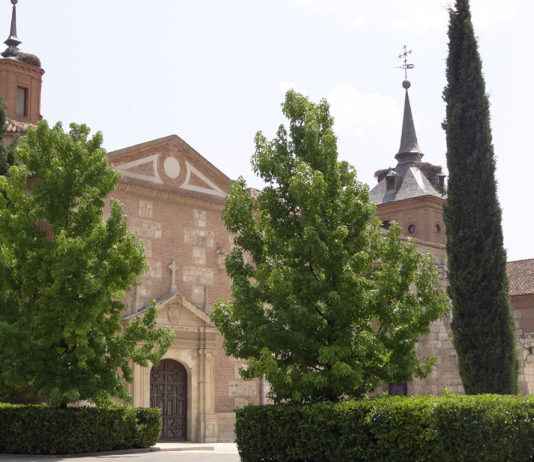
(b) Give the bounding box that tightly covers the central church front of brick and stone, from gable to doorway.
[105,136,264,442]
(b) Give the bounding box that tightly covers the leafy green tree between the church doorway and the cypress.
[212,91,447,402]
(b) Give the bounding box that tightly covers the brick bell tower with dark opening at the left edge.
[0,0,44,141]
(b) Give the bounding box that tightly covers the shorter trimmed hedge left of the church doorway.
[0,404,161,454]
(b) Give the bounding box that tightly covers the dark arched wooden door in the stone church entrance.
[150,359,187,441]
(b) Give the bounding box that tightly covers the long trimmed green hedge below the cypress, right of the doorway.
[236,395,534,462]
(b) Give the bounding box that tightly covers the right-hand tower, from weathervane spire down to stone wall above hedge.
[369,47,463,395]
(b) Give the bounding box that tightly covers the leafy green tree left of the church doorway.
[0,122,171,406]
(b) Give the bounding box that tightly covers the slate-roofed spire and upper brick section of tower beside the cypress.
[370,47,445,247]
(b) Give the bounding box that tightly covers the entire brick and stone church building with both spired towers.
[0,0,534,442]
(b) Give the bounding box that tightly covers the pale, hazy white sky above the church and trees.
[0,0,534,260]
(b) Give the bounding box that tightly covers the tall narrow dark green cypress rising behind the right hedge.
[444,0,518,394]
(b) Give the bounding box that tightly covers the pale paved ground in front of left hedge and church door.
[0,444,240,462]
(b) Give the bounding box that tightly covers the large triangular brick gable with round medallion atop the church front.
[109,135,231,199]
